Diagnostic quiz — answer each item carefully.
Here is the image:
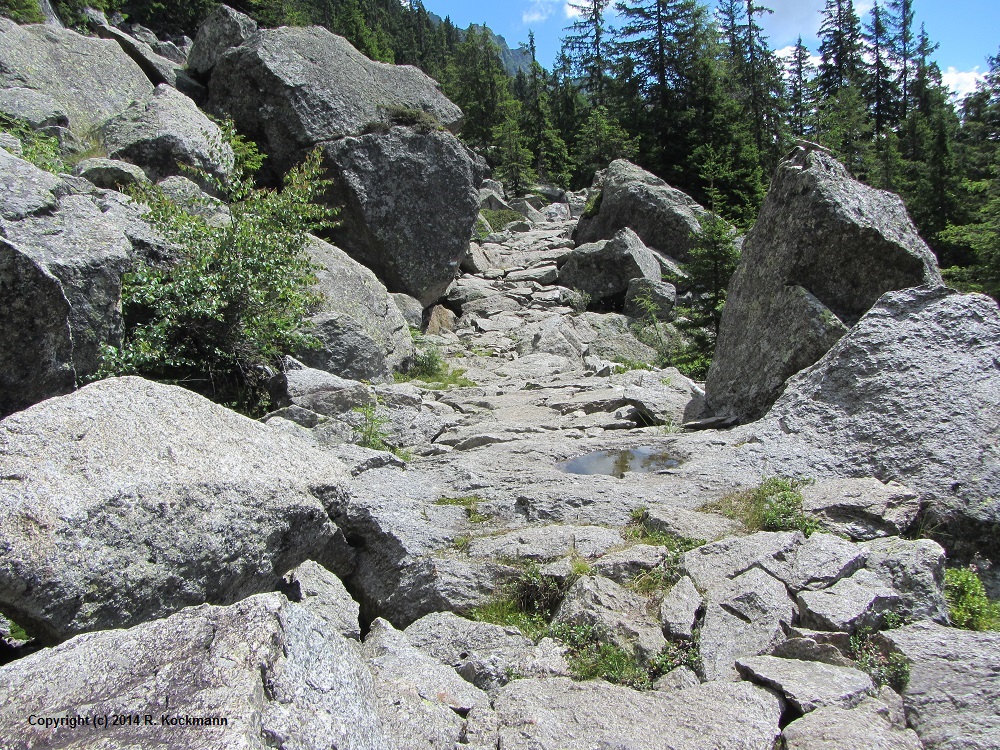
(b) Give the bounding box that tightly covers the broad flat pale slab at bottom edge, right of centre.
[494,678,782,750]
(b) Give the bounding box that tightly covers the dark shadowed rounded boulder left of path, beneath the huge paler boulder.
[323,127,481,306]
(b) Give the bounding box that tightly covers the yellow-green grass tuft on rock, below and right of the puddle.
[702,477,819,536]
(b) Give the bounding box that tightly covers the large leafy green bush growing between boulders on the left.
[99,123,335,415]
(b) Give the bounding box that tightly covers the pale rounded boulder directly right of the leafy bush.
[300,239,415,381]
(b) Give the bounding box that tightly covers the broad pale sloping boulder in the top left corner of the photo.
[0,18,153,134]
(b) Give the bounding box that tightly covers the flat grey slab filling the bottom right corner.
[883,622,1000,750]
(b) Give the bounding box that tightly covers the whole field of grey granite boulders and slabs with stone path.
[0,6,1000,750]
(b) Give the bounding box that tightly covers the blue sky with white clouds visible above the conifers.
[424,0,1000,100]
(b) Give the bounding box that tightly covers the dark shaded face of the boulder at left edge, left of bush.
[0,239,76,417]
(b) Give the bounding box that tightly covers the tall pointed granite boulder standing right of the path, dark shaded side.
[705,148,942,421]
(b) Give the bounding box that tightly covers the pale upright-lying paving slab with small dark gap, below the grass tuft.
[699,567,796,680]
